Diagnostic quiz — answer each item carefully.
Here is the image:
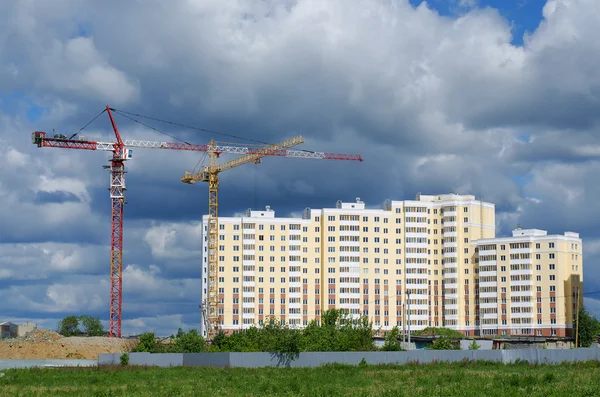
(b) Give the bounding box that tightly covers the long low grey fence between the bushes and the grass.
[98,347,600,368]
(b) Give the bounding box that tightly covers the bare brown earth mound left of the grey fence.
[0,330,138,360]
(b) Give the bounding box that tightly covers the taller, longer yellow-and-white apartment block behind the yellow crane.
[201,194,581,335]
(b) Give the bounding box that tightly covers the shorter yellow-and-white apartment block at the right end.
[473,228,583,336]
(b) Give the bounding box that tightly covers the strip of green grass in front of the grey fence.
[0,362,600,397]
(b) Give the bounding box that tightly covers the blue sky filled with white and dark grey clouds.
[0,0,600,335]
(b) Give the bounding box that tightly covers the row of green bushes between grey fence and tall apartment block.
[133,309,402,358]
